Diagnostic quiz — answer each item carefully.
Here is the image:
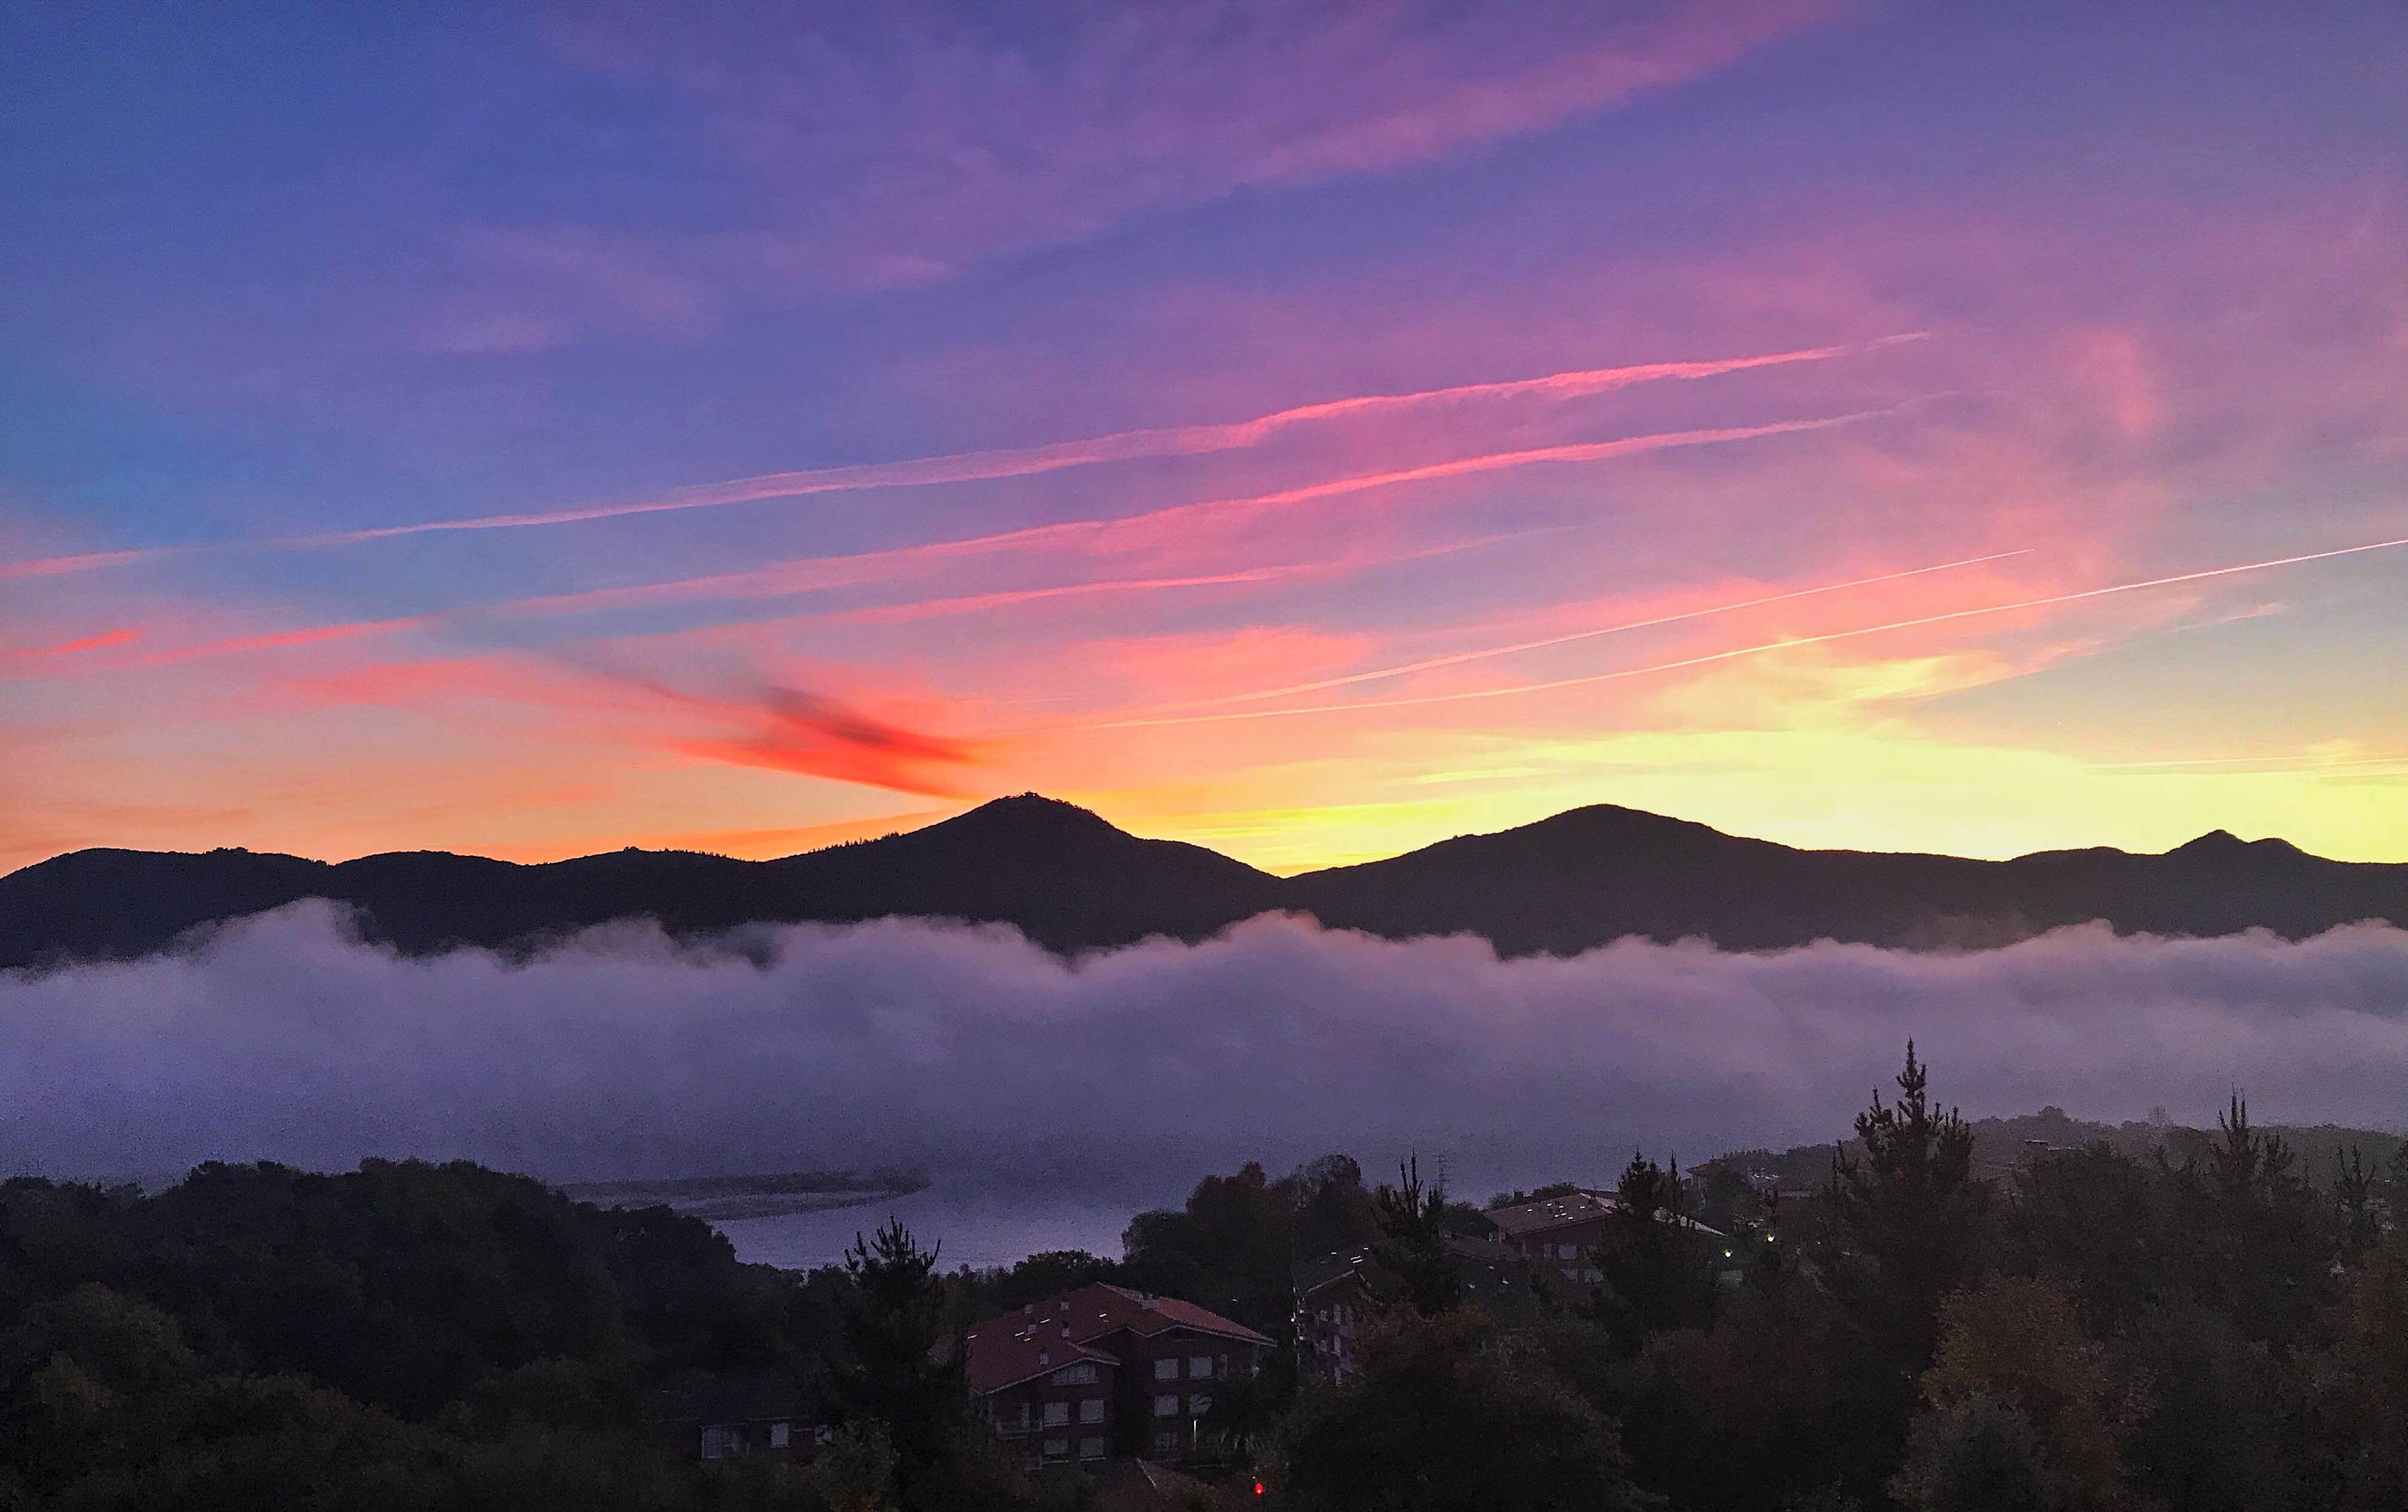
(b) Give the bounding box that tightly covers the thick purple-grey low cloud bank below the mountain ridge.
[0,903,2408,1197]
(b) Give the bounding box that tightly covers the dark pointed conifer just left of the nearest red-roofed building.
[831,1218,968,1486]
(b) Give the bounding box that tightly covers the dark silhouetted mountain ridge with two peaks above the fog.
[0,795,2408,968]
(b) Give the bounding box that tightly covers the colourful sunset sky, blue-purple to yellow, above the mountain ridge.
[0,0,2408,872]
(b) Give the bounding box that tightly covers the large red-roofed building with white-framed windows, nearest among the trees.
[963,1281,1271,1466]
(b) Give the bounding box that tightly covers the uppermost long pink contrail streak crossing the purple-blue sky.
[0,332,1924,580]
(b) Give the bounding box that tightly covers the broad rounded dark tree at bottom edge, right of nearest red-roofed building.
[1281,1307,1650,1512]
